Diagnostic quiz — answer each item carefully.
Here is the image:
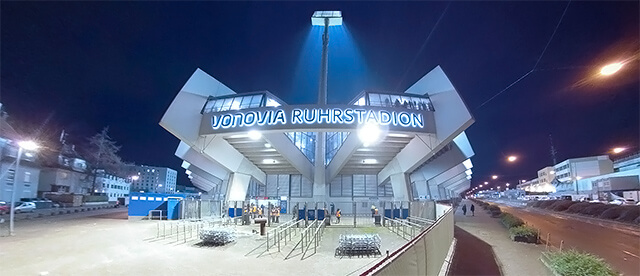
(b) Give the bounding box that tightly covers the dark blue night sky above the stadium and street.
[0,1,640,190]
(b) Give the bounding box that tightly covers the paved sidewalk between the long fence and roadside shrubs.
[454,200,549,276]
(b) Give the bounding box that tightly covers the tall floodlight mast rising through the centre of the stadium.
[311,11,342,201]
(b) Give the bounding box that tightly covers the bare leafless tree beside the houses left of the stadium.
[85,127,126,194]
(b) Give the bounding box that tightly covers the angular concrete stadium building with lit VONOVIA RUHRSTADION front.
[160,66,474,206]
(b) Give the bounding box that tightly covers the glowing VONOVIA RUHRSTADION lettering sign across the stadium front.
[200,105,433,134]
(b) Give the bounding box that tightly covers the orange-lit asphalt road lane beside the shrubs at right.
[501,206,640,275]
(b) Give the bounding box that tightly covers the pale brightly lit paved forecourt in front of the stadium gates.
[0,209,405,275]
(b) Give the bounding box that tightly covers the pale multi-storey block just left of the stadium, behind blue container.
[129,165,178,193]
